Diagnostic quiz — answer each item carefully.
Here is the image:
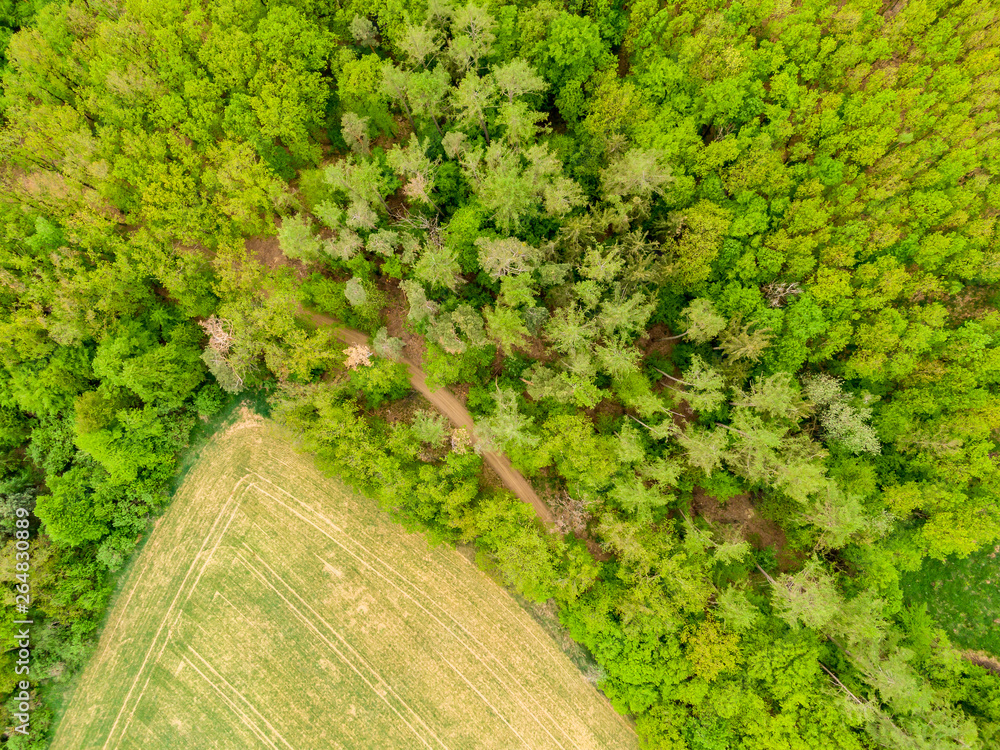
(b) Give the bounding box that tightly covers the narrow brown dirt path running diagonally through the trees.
[303,310,555,530]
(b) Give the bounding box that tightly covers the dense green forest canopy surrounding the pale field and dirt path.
[0,0,1000,750]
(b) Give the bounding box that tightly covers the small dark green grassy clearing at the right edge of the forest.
[903,544,1000,656]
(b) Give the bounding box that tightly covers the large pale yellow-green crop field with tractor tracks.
[52,413,637,750]
